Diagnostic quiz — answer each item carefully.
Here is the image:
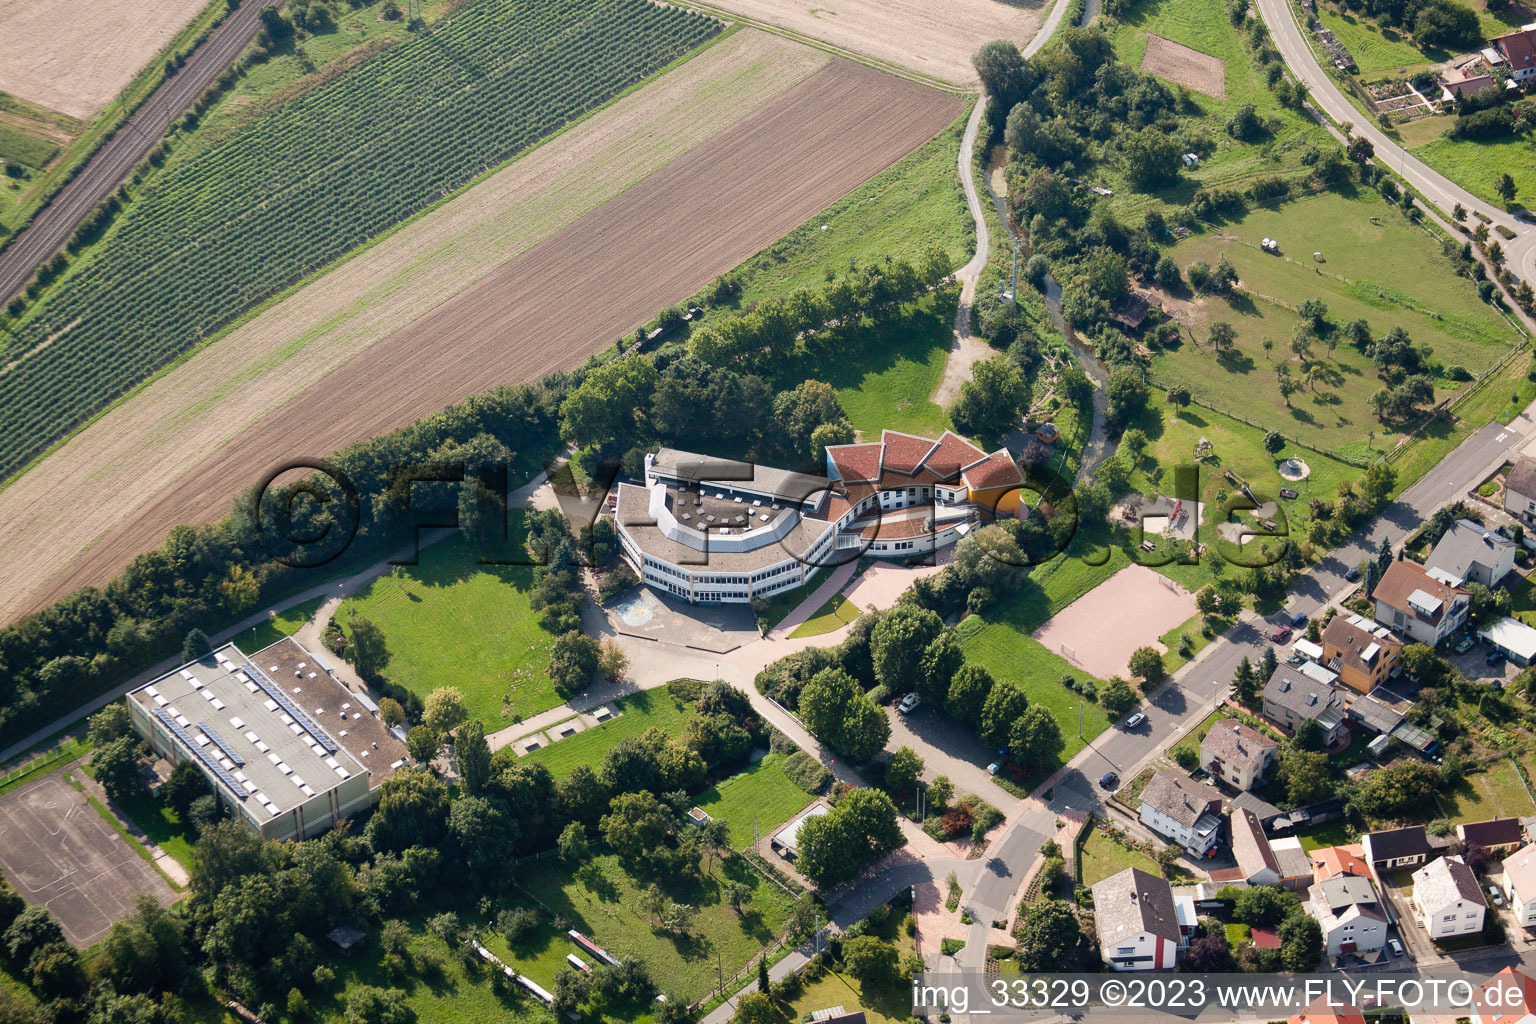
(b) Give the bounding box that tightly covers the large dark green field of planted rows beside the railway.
[0,0,720,476]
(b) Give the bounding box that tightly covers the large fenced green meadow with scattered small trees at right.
[1152,190,1521,457]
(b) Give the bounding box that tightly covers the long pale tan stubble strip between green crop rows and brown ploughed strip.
[0,32,829,619]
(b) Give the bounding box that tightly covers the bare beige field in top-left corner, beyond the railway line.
[0,0,204,118]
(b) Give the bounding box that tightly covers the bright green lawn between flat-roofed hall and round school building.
[336,528,562,732]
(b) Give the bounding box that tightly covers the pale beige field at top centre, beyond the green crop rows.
[713,0,1049,84]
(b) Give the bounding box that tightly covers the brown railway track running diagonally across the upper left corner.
[0,0,281,302]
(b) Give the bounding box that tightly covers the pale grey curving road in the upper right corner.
[1258,0,1536,282]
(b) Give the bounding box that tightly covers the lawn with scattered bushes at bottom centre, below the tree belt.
[516,855,791,1001]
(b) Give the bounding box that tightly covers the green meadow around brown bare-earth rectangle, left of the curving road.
[1095,0,1335,214]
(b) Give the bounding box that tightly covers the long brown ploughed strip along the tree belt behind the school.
[15,60,963,611]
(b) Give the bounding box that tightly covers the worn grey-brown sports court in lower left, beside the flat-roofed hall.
[0,766,177,949]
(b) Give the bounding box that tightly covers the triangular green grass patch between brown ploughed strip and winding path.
[706,117,975,309]
